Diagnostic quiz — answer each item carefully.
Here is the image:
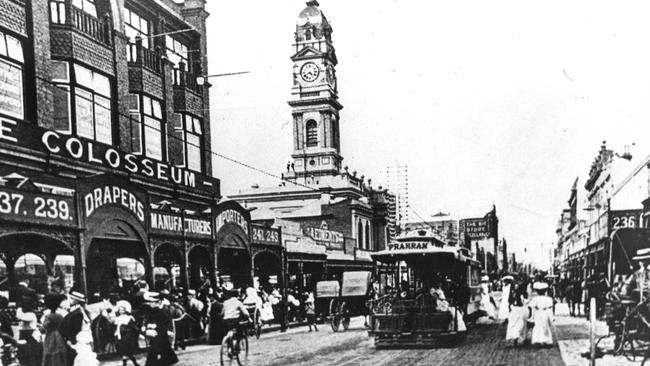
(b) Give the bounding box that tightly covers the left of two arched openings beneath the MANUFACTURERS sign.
[153,243,183,291]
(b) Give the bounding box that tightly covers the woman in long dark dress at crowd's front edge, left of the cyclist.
[142,292,178,366]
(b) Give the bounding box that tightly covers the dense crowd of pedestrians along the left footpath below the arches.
[0,280,326,366]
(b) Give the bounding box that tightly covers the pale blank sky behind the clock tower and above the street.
[207,0,650,264]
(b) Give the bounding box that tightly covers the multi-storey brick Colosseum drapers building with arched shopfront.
[0,0,280,300]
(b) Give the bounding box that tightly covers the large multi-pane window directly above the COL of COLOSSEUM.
[52,61,113,145]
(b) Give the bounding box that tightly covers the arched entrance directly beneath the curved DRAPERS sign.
[86,219,151,300]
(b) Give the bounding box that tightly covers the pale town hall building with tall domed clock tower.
[229,1,395,287]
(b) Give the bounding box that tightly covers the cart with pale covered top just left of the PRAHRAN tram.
[316,271,371,332]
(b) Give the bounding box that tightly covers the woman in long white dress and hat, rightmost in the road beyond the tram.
[528,282,553,346]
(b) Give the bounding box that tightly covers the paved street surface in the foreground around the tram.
[98,318,564,366]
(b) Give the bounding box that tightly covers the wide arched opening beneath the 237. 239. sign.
[0,232,74,301]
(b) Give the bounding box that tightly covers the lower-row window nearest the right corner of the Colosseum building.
[174,114,203,172]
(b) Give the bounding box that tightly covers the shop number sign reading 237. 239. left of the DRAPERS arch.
[0,187,77,226]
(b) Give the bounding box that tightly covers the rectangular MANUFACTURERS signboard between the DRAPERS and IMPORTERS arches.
[149,210,212,238]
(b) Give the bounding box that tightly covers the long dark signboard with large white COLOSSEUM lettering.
[0,119,219,191]
